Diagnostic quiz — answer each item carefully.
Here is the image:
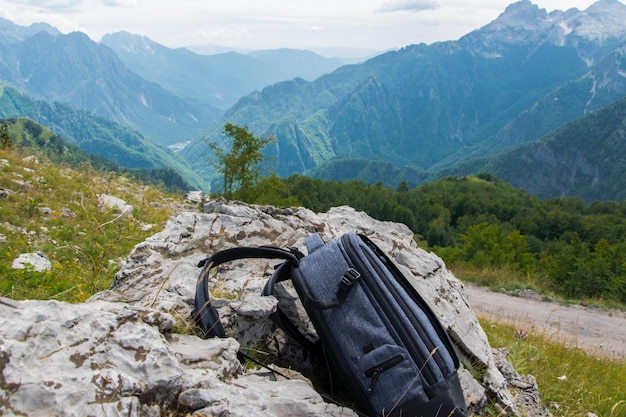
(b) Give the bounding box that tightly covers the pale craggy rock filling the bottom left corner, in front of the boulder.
[0,299,241,416]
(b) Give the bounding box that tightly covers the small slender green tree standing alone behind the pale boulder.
[209,123,276,198]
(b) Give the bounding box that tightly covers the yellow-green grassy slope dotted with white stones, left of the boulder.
[0,149,180,302]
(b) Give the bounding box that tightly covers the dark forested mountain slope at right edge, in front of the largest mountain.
[437,97,626,202]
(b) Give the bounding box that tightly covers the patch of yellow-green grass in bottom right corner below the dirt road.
[480,319,626,417]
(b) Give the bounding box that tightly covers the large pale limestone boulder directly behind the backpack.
[93,200,536,415]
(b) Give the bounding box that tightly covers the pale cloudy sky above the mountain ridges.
[0,0,608,52]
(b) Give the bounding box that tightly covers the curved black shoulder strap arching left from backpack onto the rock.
[193,246,302,339]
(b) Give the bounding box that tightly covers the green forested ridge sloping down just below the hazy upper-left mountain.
[0,81,205,188]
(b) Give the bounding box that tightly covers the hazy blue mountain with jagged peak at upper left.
[0,21,222,145]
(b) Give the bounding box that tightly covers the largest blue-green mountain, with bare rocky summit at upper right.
[181,0,626,197]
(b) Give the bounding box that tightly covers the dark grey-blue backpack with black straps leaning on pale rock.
[194,232,467,417]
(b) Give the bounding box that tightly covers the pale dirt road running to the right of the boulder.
[465,283,626,359]
